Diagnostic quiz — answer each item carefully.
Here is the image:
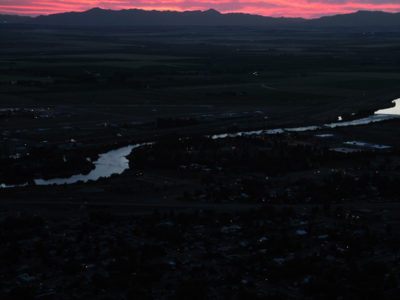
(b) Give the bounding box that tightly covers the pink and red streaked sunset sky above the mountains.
[0,0,400,18]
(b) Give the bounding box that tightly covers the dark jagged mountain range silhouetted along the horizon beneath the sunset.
[0,7,400,30]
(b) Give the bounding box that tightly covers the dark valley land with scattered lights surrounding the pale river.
[0,25,400,299]
